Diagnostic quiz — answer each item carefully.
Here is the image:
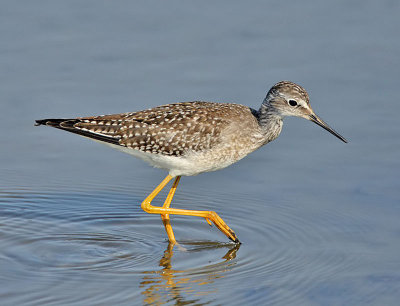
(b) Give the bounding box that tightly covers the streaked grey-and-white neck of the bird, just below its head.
[258,103,283,142]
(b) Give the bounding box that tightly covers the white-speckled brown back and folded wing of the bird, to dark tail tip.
[38,101,266,156]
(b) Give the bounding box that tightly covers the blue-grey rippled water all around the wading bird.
[0,1,400,305]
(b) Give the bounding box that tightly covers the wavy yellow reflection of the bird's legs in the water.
[140,242,240,305]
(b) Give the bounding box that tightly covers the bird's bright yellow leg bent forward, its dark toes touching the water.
[142,175,239,243]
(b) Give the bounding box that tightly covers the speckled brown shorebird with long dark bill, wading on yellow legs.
[36,81,347,244]
